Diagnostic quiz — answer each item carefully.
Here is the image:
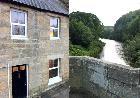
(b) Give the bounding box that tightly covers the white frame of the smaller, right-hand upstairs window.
[50,16,60,40]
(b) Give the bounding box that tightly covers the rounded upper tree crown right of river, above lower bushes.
[113,10,140,42]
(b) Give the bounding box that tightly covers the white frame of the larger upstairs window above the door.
[10,8,27,39]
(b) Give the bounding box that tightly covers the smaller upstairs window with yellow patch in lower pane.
[50,17,59,40]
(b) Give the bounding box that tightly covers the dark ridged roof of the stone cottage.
[3,0,69,15]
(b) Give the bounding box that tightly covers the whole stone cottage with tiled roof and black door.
[0,0,69,98]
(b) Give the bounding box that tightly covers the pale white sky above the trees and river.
[69,0,140,26]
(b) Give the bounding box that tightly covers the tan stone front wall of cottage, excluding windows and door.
[0,2,69,98]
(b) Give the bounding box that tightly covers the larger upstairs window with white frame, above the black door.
[10,9,27,39]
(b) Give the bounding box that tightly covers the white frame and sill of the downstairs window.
[48,58,62,85]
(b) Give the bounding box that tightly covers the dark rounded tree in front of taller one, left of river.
[70,20,93,48]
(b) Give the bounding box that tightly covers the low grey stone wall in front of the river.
[70,57,140,98]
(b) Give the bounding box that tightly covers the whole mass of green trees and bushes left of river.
[70,12,104,57]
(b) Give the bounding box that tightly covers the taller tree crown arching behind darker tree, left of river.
[70,12,103,38]
